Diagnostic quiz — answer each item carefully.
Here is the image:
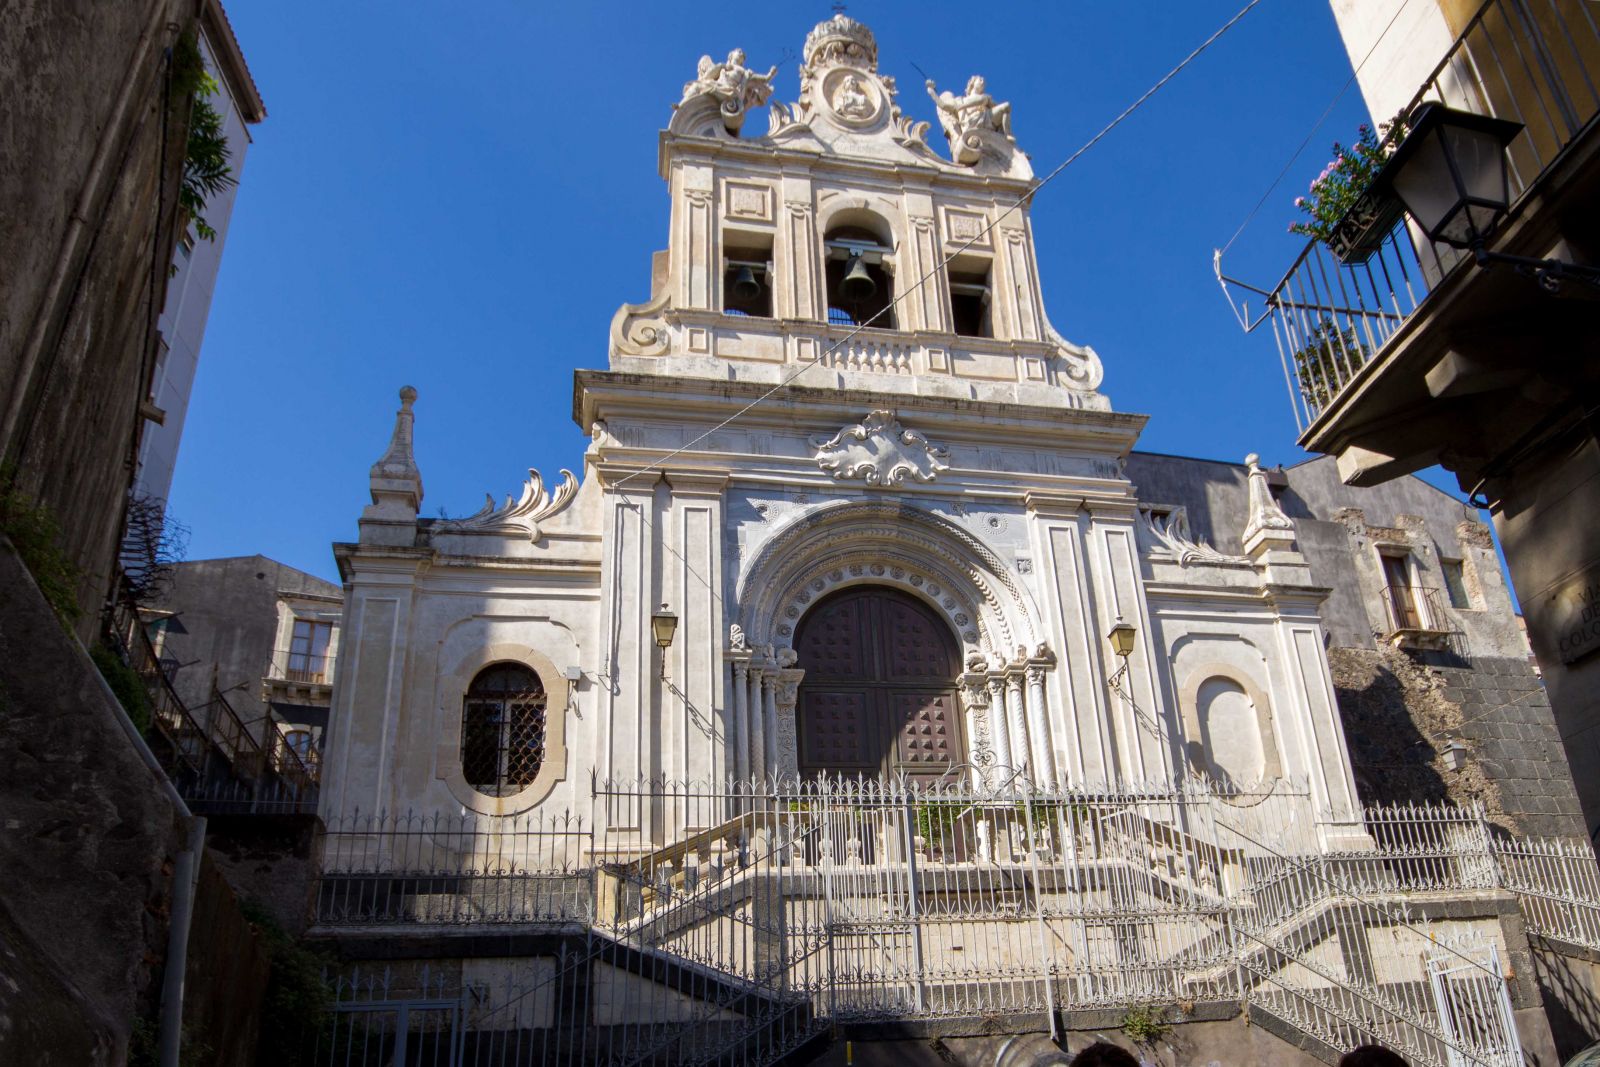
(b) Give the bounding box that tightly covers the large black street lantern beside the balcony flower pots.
[1373,104,1522,248]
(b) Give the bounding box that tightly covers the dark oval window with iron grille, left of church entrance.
[461,664,546,797]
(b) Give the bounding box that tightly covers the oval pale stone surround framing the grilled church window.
[434,641,571,816]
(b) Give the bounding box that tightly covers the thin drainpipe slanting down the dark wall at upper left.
[0,3,178,453]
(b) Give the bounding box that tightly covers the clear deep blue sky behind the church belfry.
[171,0,1448,577]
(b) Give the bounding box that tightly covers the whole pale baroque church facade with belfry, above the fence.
[323,16,1362,848]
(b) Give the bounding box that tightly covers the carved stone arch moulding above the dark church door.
[739,501,1043,662]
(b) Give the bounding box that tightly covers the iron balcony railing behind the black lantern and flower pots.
[1218,0,1600,432]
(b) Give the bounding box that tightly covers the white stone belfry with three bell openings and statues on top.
[610,14,1110,411]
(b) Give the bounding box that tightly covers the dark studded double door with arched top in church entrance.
[794,585,966,779]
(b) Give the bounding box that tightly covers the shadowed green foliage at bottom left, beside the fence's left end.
[238,901,333,1067]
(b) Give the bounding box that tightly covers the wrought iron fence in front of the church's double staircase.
[305,779,1600,1067]
